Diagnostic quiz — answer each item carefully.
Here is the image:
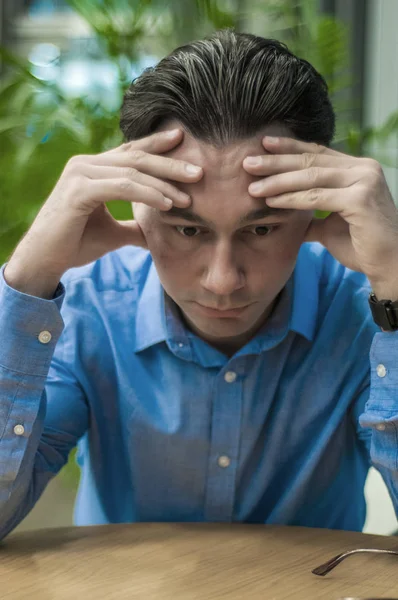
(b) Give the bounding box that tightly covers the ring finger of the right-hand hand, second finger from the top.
[243,153,358,176]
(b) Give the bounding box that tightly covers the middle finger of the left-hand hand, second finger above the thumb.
[82,164,191,208]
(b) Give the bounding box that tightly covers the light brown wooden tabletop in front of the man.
[0,523,398,600]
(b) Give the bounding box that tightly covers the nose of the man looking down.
[202,242,245,296]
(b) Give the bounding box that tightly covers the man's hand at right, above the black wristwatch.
[243,137,398,300]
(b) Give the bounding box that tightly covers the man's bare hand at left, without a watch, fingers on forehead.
[6,129,203,280]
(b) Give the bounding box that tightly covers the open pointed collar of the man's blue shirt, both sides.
[134,243,319,360]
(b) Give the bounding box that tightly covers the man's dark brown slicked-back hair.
[120,29,335,146]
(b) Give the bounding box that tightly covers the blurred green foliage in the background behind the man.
[0,0,398,486]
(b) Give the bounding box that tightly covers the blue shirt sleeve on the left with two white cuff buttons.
[0,263,88,540]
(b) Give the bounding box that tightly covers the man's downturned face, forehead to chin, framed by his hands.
[134,122,313,355]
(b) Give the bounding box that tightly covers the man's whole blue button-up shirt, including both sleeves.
[0,243,398,538]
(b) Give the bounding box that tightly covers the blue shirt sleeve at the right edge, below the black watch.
[355,332,398,518]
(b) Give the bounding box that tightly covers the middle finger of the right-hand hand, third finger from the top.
[249,167,363,198]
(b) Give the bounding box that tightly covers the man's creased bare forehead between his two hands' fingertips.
[161,122,289,225]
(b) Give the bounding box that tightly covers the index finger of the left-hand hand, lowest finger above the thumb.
[85,177,173,210]
